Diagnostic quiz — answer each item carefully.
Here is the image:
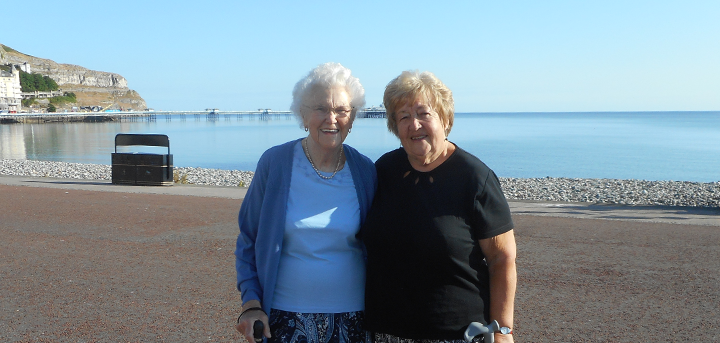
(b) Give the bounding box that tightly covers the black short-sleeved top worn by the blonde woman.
[363,147,513,339]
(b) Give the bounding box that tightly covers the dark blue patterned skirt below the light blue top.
[268,309,370,343]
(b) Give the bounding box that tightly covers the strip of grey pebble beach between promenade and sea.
[0,159,720,207]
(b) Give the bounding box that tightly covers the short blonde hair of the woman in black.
[383,70,455,136]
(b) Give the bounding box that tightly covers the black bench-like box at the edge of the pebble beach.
[112,133,173,186]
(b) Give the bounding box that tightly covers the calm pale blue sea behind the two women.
[0,112,720,182]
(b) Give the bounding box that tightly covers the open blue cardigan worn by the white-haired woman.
[235,139,377,313]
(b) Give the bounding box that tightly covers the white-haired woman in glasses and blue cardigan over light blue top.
[235,63,377,342]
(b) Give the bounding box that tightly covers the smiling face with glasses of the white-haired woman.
[301,86,352,153]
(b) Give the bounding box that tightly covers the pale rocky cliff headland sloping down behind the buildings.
[0,44,147,110]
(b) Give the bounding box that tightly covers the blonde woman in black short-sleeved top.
[363,71,517,343]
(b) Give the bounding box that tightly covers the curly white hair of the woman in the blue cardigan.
[290,62,365,127]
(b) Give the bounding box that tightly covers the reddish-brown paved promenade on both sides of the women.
[0,176,720,342]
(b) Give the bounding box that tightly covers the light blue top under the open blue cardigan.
[273,142,365,313]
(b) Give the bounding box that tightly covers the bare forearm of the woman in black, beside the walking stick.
[480,230,517,342]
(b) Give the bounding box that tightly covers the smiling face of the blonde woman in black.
[395,97,447,166]
